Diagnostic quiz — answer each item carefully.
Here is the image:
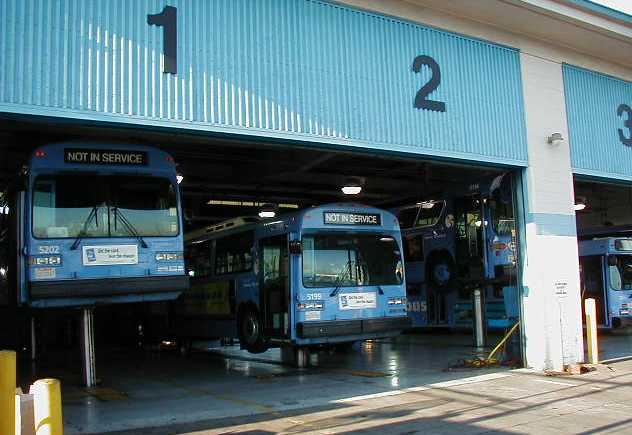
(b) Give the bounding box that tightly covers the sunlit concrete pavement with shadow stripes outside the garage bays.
[119,361,632,435]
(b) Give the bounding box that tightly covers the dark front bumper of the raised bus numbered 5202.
[30,275,189,301]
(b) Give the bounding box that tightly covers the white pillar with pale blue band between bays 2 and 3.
[520,53,584,370]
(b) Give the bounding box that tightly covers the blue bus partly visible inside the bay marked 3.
[579,237,632,329]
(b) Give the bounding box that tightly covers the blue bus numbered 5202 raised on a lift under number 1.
[0,143,188,308]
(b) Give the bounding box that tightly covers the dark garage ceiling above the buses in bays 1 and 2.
[0,119,500,226]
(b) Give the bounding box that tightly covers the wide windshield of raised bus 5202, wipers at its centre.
[33,174,179,239]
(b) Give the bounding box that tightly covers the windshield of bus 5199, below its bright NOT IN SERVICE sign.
[303,233,403,287]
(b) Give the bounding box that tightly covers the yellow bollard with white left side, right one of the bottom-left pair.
[31,379,64,435]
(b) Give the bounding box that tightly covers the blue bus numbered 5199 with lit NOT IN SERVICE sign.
[176,204,409,353]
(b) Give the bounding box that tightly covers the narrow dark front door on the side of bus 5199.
[259,234,290,338]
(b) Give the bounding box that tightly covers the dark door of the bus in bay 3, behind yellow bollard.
[579,255,608,325]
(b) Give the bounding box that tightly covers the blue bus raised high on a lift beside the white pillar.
[393,174,516,328]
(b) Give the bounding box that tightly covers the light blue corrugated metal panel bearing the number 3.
[563,65,632,180]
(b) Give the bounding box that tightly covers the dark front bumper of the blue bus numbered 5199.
[296,316,411,338]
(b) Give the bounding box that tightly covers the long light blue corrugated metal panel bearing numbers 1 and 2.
[0,0,527,165]
